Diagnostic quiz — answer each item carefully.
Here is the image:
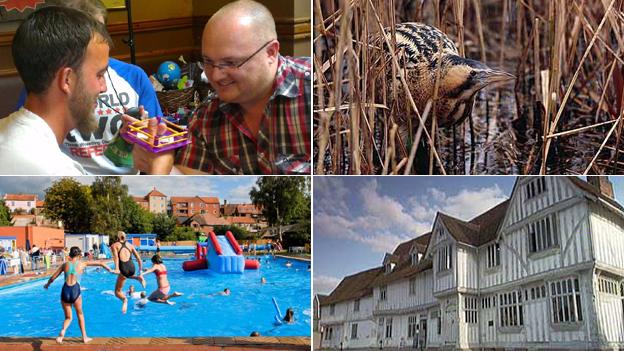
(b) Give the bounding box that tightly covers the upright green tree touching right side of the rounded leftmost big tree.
[91,177,128,235]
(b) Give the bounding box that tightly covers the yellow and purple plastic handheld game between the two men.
[124,109,190,153]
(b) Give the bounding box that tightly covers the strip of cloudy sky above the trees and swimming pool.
[0,176,258,203]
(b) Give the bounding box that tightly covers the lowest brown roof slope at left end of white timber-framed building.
[321,267,382,306]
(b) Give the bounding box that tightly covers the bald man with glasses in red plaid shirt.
[128,0,311,174]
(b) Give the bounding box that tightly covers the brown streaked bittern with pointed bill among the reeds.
[384,22,515,173]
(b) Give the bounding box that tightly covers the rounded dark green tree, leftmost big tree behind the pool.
[43,178,93,233]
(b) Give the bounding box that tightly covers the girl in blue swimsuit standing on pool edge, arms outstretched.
[43,246,113,344]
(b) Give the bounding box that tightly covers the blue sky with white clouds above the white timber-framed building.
[313,176,624,294]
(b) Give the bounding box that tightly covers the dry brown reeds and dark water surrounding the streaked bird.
[313,0,624,174]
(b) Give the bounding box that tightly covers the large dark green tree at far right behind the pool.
[249,177,310,241]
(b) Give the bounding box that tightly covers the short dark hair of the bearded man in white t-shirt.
[12,6,112,94]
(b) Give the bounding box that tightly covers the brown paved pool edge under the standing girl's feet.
[0,336,311,351]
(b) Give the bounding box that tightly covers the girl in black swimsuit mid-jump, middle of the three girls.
[111,231,145,313]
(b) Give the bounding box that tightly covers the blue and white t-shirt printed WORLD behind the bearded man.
[18,57,162,174]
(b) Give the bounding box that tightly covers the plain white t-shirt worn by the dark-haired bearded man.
[0,107,86,175]
